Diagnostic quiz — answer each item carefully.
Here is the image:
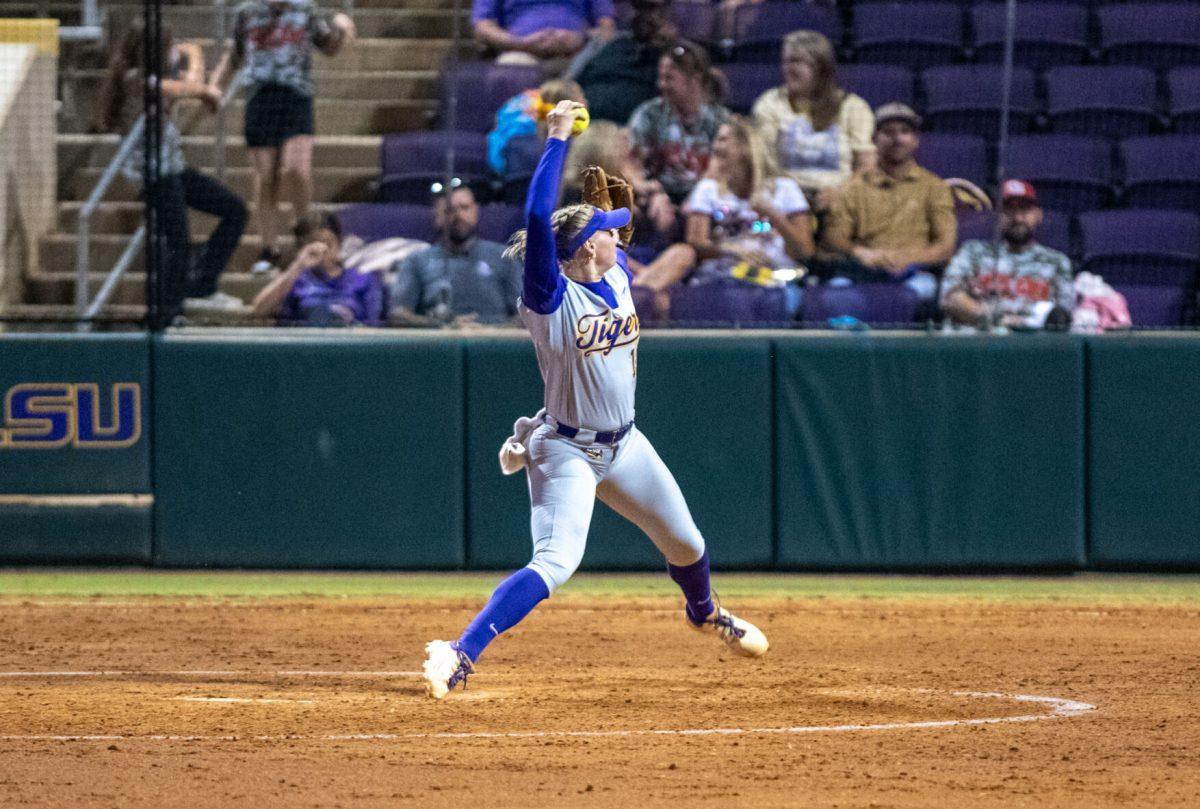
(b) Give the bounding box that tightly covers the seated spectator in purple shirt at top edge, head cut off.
[470,0,617,65]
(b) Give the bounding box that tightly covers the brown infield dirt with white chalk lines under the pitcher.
[0,588,1200,809]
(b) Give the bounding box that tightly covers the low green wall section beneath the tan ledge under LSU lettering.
[0,503,150,564]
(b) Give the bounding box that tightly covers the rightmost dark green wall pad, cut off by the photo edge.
[1087,335,1200,570]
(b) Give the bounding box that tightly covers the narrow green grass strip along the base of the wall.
[0,568,1200,604]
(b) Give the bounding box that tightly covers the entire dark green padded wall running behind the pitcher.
[7,331,1200,570]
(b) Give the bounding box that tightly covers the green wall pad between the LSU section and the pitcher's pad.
[148,334,464,569]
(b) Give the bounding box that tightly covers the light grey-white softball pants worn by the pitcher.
[527,425,704,593]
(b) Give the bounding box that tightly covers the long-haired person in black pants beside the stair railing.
[97,23,246,320]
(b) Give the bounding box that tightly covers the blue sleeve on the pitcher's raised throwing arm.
[521,138,566,314]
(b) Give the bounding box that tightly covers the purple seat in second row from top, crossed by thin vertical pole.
[922,65,1037,136]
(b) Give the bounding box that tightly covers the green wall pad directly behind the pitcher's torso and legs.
[467,334,773,570]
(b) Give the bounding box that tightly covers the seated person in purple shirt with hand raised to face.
[253,216,383,326]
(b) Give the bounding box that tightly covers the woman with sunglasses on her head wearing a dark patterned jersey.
[629,40,730,204]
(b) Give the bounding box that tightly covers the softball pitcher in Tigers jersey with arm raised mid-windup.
[424,101,767,700]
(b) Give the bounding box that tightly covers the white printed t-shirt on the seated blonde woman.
[684,176,809,269]
